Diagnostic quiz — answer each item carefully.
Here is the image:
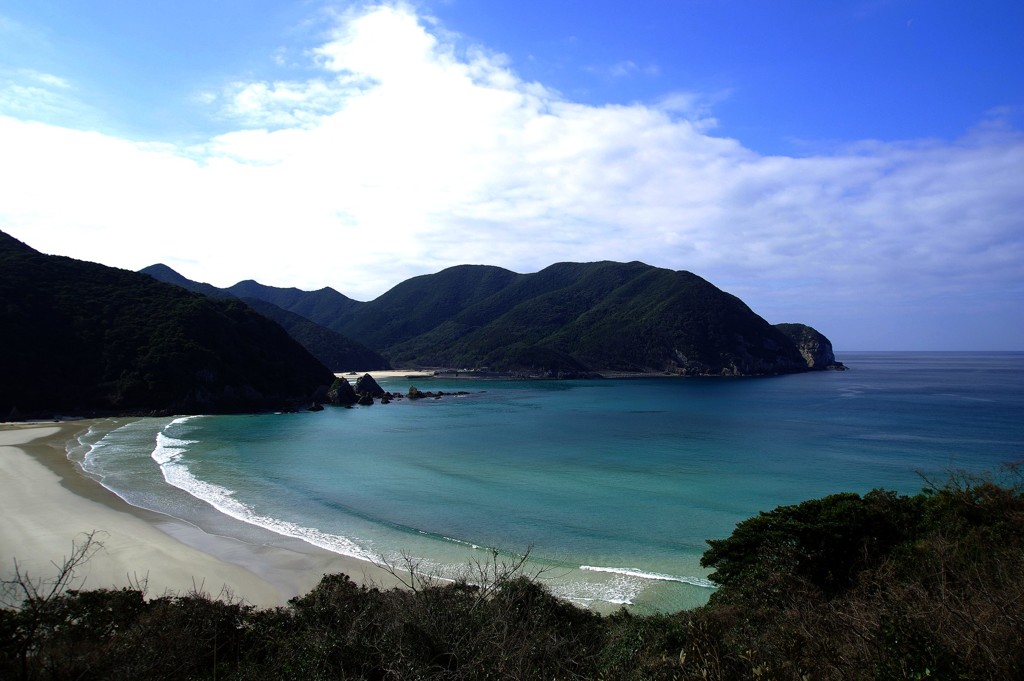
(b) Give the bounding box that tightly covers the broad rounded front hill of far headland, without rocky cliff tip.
[382,262,808,375]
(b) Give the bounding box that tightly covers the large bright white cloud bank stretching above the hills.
[0,5,1024,347]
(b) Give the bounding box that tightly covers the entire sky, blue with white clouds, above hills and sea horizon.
[0,0,1024,350]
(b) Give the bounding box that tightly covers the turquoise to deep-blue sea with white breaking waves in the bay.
[69,352,1024,613]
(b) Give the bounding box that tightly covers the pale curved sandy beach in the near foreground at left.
[0,421,407,607]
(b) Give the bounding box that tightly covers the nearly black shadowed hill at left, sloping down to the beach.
[0,232,334,418]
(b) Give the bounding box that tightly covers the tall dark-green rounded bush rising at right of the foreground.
[694,467,1024,679]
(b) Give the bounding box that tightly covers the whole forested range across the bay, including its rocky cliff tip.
[153,262,841,376]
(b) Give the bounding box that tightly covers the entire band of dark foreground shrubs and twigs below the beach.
[0,469,1024,681]
